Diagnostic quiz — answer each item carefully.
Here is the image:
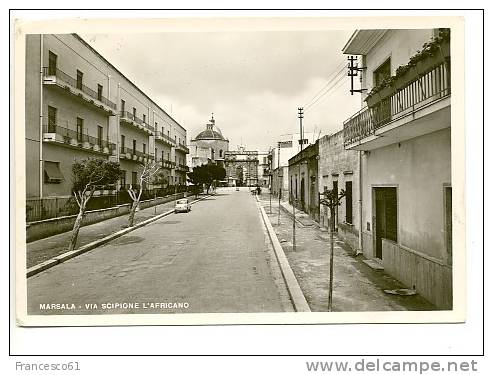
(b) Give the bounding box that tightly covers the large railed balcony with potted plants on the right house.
[344,60,451,151]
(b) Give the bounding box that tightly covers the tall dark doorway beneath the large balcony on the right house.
[374,187,397,259]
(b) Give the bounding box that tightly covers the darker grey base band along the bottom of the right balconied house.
[382,239,452,309]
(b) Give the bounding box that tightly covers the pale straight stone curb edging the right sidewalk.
[256,197,311,312]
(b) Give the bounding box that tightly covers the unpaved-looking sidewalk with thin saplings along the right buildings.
[258,194,436,311]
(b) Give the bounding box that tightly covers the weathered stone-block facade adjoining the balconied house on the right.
[318,130,361,251]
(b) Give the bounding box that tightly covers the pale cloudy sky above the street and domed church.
[81,30,360,150]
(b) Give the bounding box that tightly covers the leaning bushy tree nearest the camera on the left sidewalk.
[68,159,121,251]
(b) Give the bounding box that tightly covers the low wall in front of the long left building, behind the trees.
[26,193,184,243]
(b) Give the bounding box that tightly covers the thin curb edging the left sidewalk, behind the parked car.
[26,194,211,278]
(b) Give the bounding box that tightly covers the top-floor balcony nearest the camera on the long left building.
[43,67,116,116]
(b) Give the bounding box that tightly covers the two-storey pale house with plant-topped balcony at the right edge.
[343,29,452,308]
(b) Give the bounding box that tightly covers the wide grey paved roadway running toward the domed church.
[27,190,292,314]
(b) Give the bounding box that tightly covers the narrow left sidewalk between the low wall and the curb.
[26,196,204,268]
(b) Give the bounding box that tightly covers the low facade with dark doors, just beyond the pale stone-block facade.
[288,141,320,222]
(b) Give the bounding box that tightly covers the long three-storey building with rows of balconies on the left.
[25,34,188,204]
